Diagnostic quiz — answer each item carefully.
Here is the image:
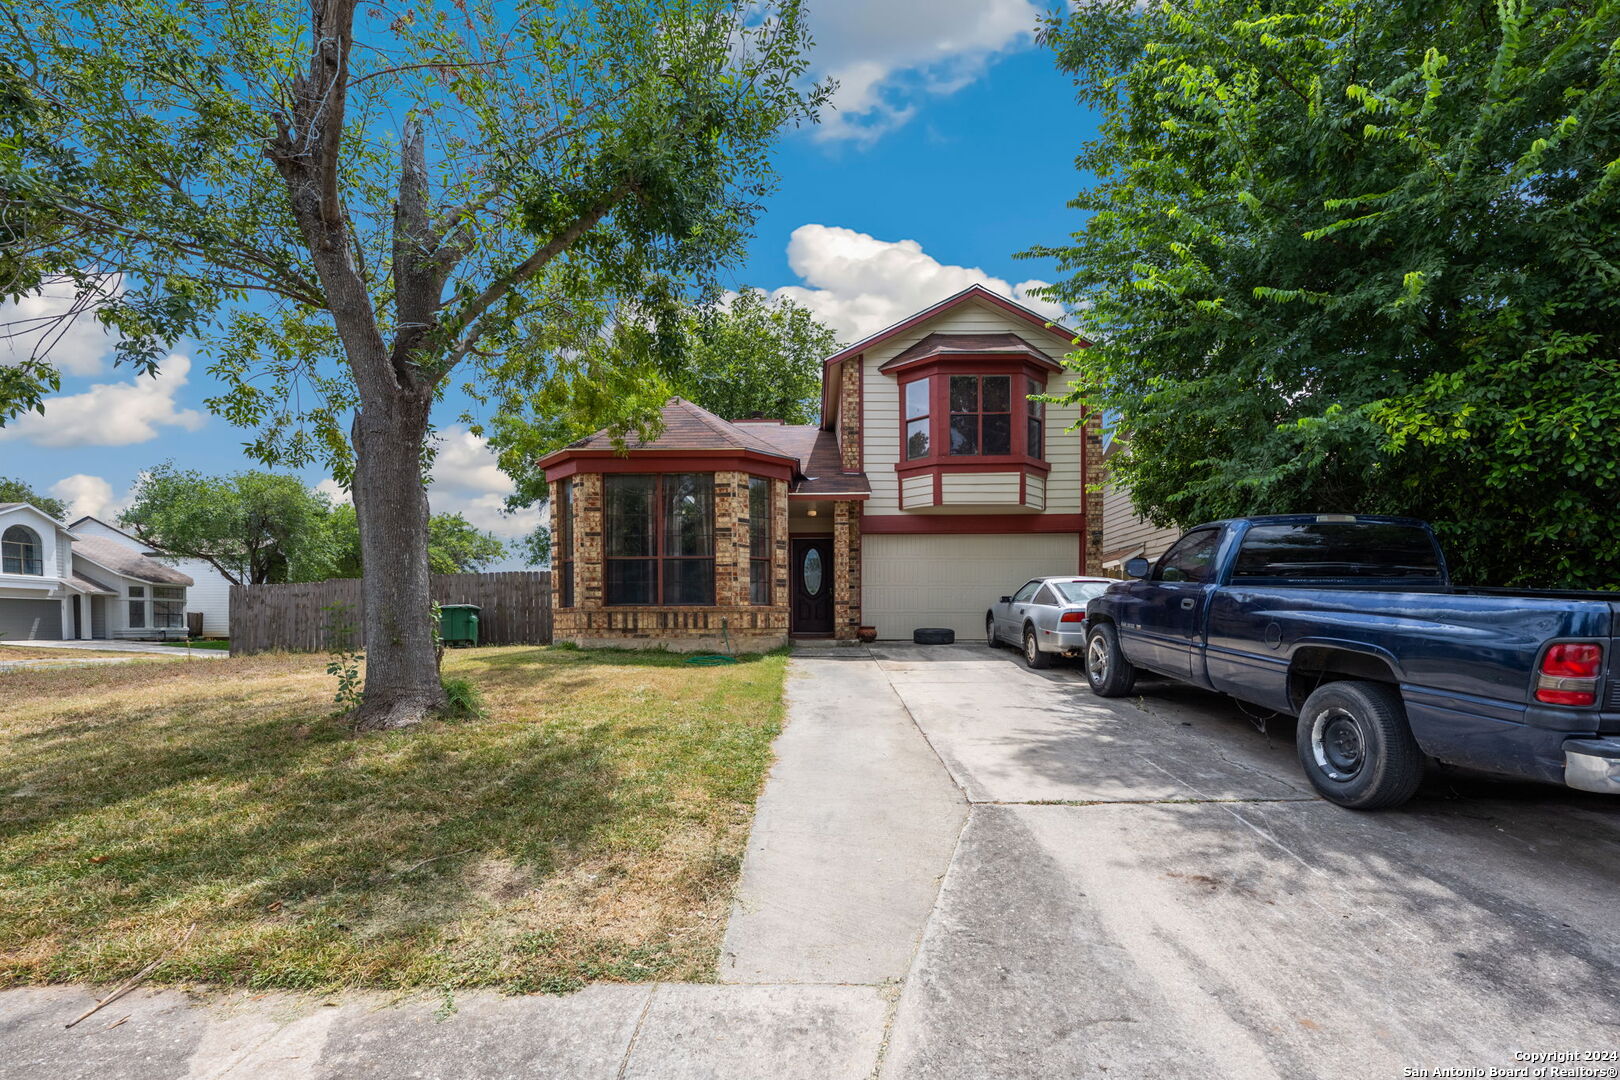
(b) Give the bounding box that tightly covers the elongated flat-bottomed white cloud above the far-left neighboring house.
[0,353,207,447]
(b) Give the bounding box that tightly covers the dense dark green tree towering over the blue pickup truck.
[1029,0,1620,586]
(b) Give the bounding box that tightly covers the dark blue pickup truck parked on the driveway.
[1085,513,1620,810]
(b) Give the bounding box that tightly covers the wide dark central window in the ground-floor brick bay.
[603,473,714,604]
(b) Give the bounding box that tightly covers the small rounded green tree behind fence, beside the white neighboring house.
[118,463,335,585]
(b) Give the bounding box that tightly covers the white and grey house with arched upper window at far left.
[0,502,191,641]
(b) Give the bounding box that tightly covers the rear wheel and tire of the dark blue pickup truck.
[1294,678,1422,810]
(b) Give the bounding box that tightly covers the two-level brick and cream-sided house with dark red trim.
[539,285,1102,649]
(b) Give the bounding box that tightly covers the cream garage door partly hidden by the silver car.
[860,533,1081,640]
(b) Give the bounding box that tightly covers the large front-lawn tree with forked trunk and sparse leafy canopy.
[0,0,826,729]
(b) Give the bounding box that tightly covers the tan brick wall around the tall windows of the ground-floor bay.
[551,471,787,653]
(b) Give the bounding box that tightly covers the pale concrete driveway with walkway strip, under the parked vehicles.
[721,644,1620,1080]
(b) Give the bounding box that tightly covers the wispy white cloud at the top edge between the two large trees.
[810,0,1040,142]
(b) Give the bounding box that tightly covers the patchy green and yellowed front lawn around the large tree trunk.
[0,648,786,991]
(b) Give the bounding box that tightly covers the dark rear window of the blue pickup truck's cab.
[1231,521,1440,583]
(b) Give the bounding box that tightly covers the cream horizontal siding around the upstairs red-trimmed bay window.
[862,293,1082,515]
